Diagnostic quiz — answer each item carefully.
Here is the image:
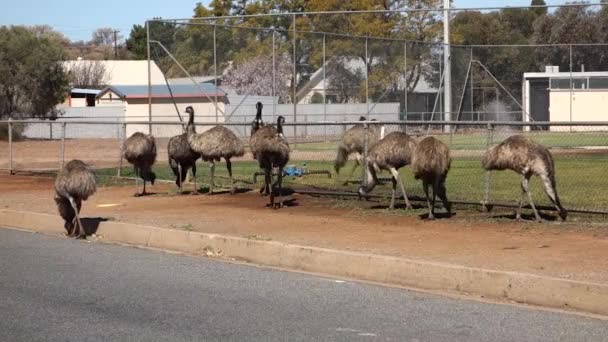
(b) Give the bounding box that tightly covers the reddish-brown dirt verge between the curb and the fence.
[0,175,608,283]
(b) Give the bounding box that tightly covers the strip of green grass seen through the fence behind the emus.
[97,155,608,211]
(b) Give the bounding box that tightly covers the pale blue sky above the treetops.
[0,0,576,40]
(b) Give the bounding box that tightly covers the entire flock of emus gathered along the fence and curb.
[55,102,568,237]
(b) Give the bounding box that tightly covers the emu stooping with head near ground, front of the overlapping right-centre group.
[359,132,416,209]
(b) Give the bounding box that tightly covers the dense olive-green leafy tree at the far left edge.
[0,26,69,118]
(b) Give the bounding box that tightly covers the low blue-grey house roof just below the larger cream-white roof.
[97,83,226,99]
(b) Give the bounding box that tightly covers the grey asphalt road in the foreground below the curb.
[0,229,608,341]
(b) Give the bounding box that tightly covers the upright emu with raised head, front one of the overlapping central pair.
[252,116,290,208]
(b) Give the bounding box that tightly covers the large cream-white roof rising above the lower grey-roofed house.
[63,59,165,85]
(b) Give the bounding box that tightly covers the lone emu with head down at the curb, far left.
[55,160,97,238]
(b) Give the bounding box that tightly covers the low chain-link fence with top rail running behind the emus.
[0,120,608,213]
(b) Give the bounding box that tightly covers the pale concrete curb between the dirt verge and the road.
[0,210,608,315]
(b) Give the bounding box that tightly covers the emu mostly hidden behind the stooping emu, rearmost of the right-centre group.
[334,116,382,183]
